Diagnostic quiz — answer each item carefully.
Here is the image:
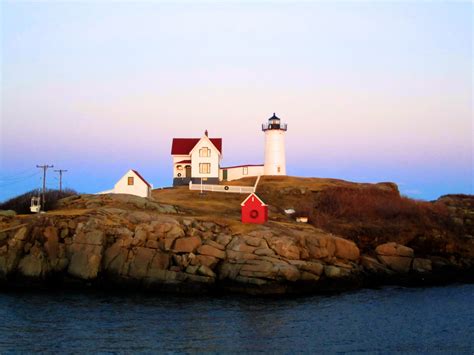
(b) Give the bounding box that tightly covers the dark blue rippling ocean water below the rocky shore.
[0,284,474,354]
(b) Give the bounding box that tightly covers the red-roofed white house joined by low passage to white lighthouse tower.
[171,114,287,186]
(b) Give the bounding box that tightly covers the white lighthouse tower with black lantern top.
[262,113,287,175]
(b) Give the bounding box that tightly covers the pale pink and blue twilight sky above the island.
[0,1,474,201]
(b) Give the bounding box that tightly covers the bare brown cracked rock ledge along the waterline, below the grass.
[0,196,473,293]
